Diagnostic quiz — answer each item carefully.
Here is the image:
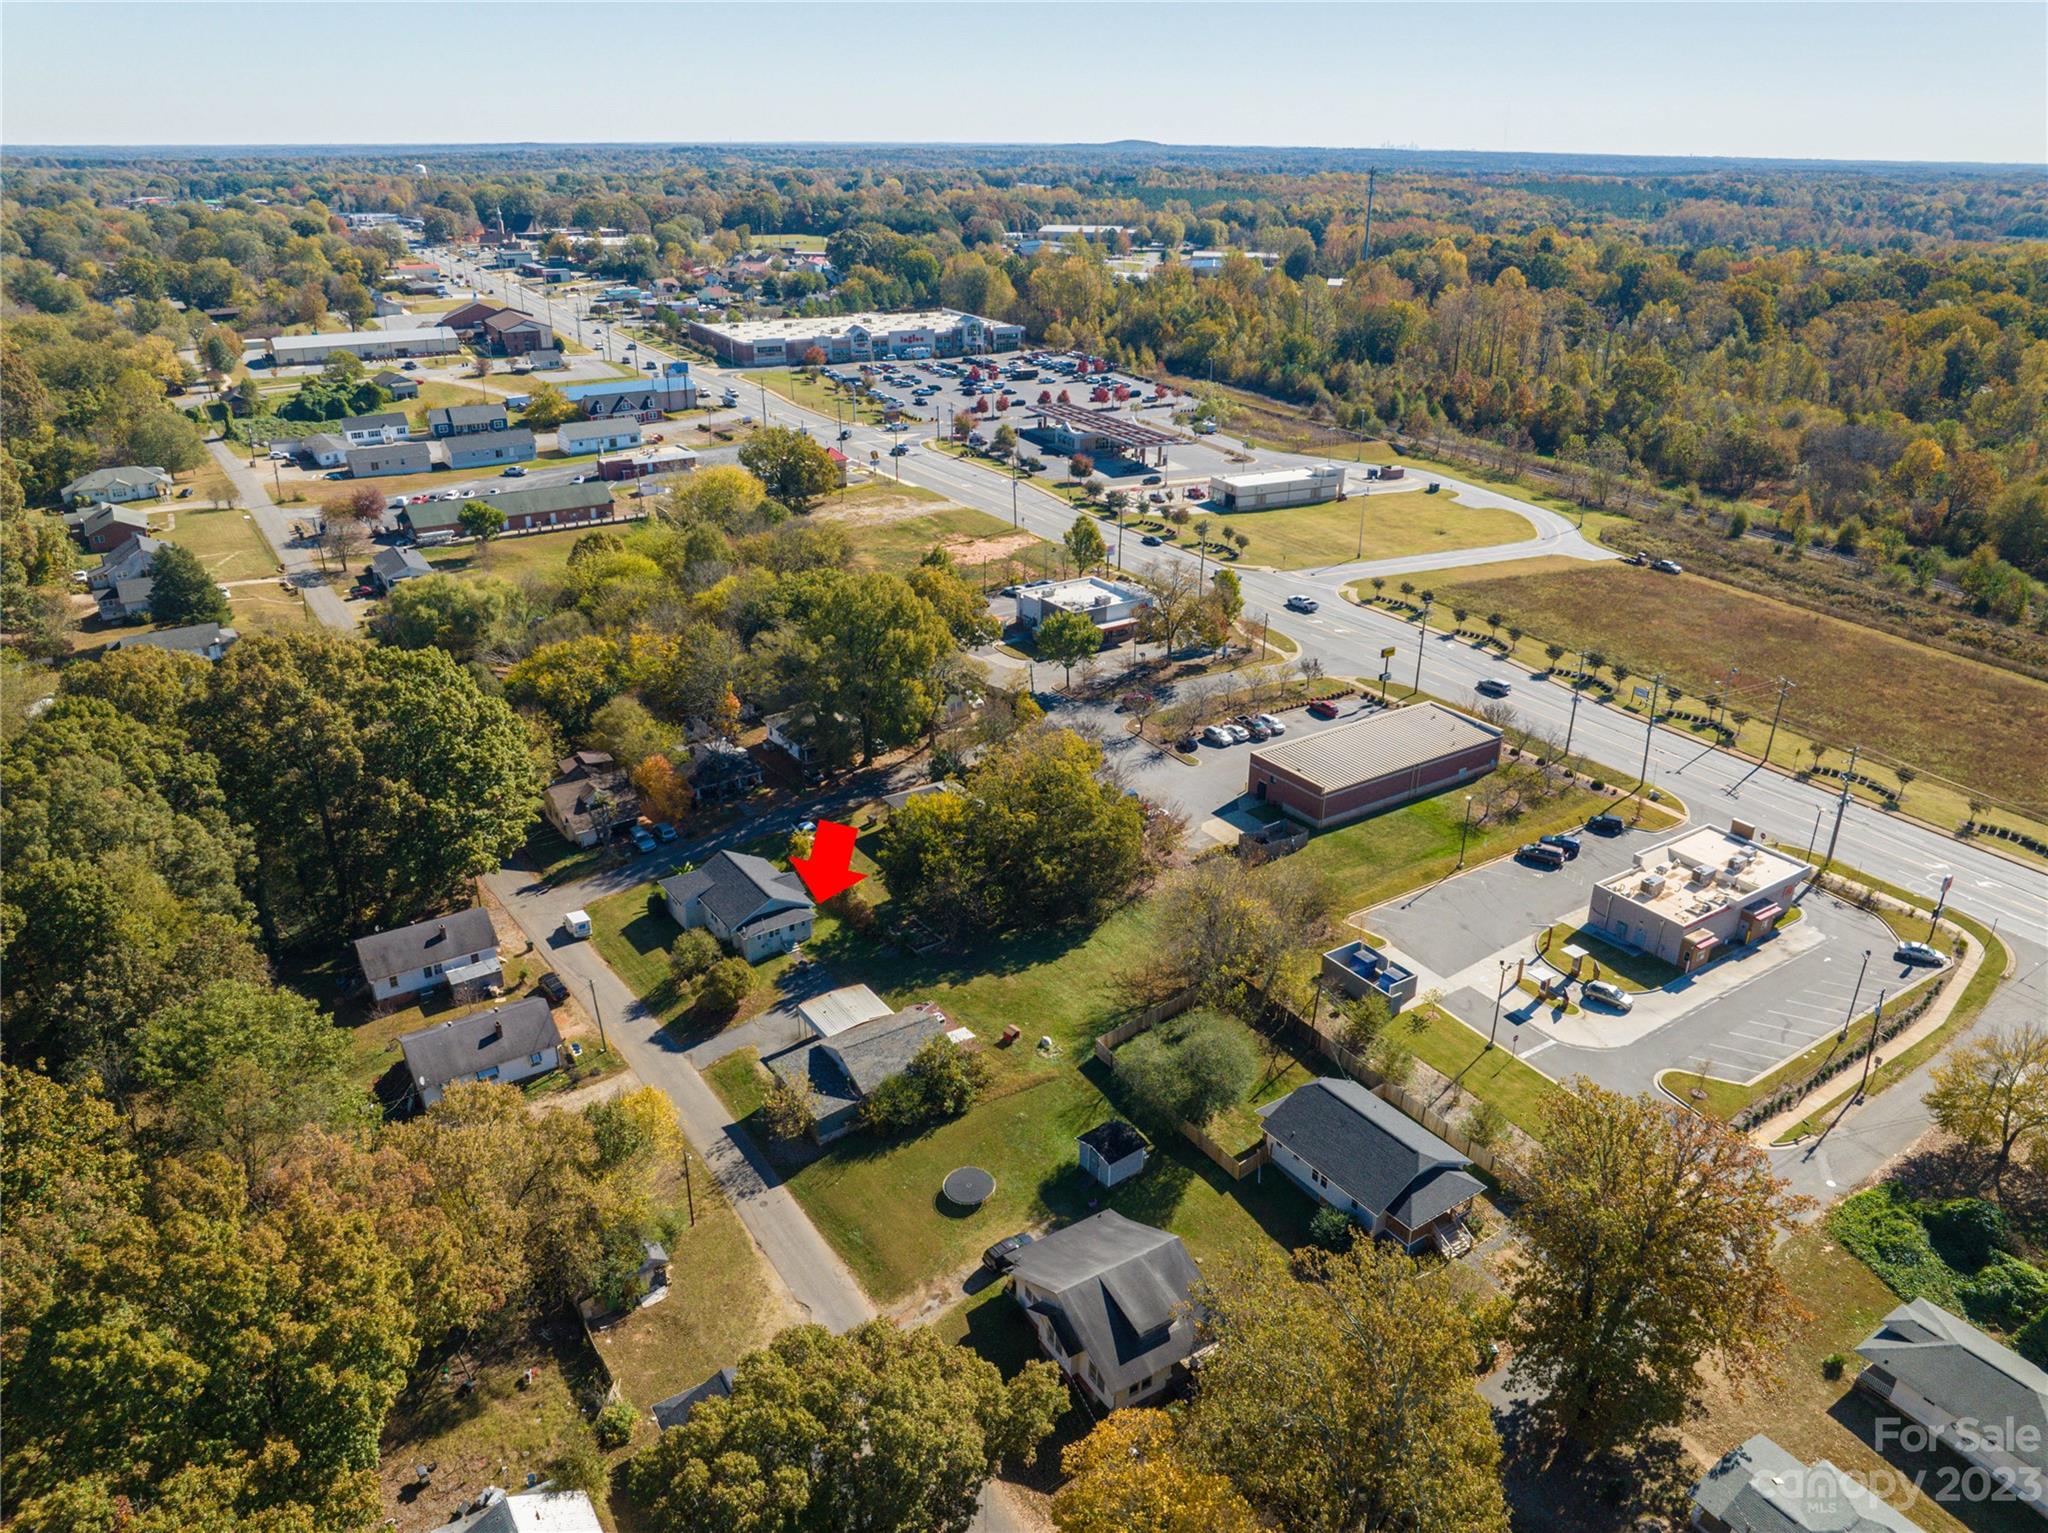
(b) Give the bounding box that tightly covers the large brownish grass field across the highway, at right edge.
[1354,559,2048,823]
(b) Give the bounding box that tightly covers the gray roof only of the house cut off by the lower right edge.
[1855,1300,2048,1474]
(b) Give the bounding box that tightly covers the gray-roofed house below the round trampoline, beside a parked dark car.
[1010,1212,1200,1392]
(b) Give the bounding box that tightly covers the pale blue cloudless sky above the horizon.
[0,0,2048,164]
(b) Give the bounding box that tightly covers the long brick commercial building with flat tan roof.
[1245,702,1501,831]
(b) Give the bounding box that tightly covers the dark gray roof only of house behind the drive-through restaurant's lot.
[1260,1079,1481,1230]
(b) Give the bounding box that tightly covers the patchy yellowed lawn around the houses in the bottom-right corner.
[1686,1226,2040,1533]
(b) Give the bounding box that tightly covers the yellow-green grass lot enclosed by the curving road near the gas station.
[1182,491,1536,569]
